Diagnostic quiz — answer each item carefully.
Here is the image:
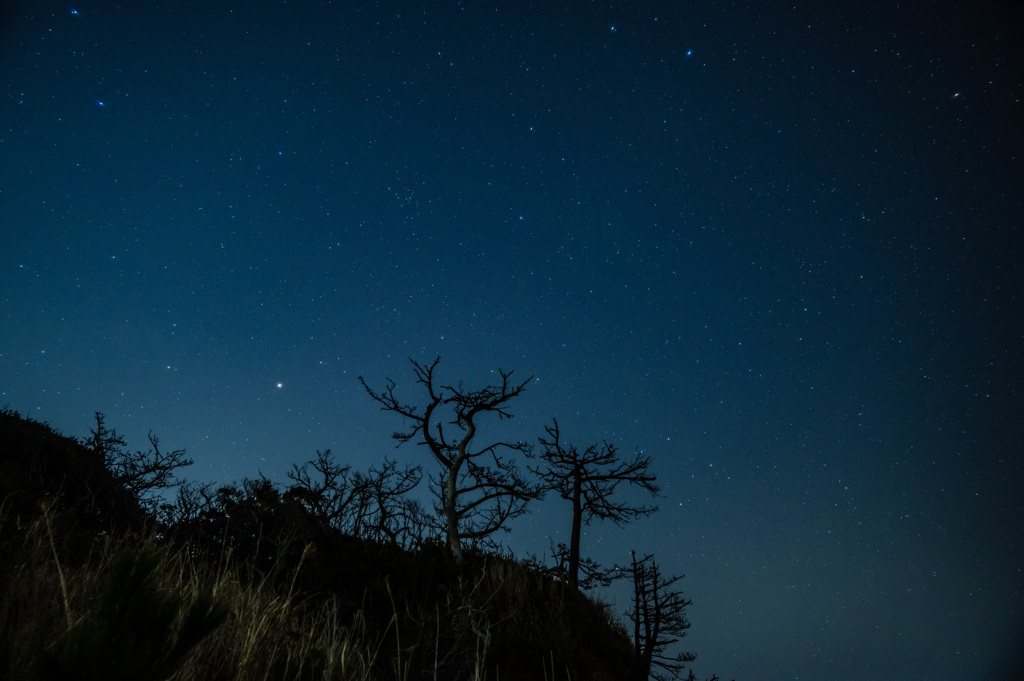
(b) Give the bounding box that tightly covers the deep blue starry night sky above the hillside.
[0,0,1024,681]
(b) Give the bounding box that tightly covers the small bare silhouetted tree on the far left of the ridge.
[82,412,194,508]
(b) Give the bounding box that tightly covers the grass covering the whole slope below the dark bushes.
[0,501,622,681]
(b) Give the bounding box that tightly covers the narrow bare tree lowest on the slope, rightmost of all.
[620,551,696,681]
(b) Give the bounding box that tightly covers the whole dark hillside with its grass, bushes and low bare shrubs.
[0,372,733,681]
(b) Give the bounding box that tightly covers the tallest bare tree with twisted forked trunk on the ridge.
[359,357,540,564]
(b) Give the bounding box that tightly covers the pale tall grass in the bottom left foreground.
[0,514,407,681]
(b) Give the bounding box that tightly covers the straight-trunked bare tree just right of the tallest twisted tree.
[530,420,657,587]
